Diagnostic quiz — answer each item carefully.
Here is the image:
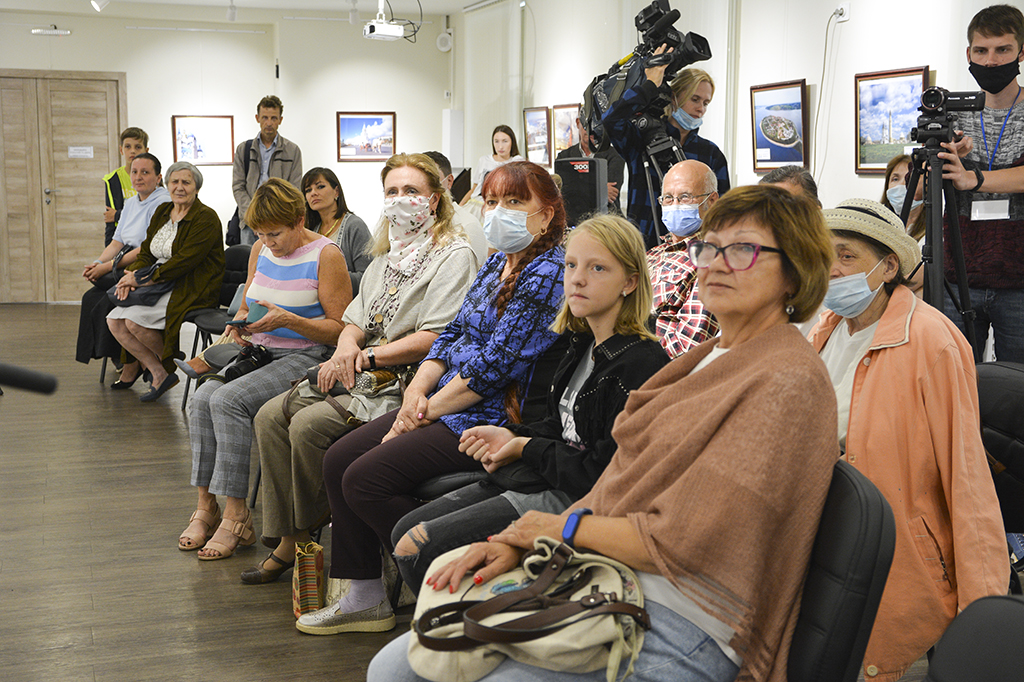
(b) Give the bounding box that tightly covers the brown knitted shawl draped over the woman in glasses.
[580,325,839,682]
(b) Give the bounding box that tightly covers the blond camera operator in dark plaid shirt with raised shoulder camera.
[602,45,729,249]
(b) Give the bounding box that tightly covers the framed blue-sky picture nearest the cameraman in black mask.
[853,67,928,175]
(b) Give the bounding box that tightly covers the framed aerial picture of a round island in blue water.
[751,79,810,173]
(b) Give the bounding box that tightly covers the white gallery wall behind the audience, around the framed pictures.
[0,0,1011,236]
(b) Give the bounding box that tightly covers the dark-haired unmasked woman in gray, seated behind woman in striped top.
[302,168,373,296]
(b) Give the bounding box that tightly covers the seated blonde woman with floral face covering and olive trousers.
[242,154,478,585]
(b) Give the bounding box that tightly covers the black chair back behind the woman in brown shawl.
[788,460,892,682]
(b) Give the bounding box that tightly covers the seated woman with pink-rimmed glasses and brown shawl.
[367,185,839,682]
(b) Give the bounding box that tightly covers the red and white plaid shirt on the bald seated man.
[647,238,719,357]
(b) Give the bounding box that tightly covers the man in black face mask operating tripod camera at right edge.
[938,5,1024,363]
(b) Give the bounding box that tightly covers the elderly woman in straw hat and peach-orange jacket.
[810,199,1010,681]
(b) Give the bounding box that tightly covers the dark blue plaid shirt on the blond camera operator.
[601,80,730,249]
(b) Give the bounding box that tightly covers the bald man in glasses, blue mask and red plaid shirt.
[647,160,719,357]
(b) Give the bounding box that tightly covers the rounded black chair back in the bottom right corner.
[925,596,1024,682]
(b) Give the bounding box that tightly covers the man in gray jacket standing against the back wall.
[231,95,302,244]
